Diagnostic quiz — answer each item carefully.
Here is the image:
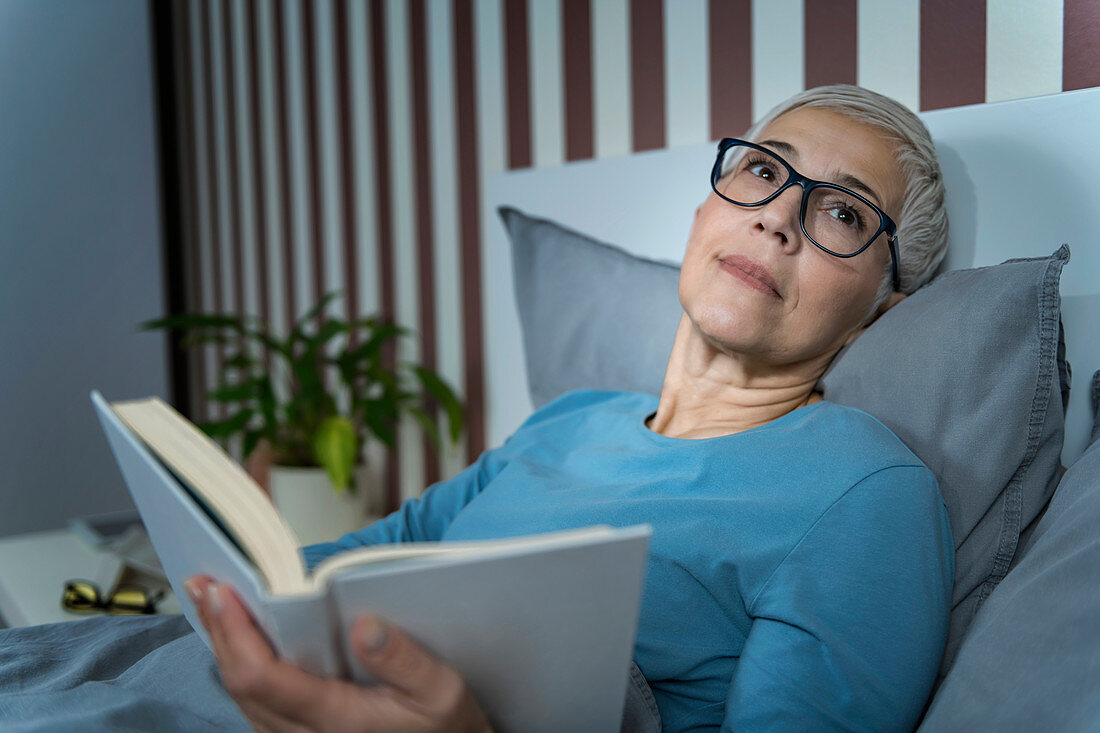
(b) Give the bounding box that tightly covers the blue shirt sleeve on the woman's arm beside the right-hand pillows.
[723,466,955,731]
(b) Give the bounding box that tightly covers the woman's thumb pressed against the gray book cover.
[352,615,461,703]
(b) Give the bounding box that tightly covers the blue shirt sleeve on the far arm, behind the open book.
[301,449,507,570]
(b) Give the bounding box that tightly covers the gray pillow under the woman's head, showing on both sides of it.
[501,209,1069,676]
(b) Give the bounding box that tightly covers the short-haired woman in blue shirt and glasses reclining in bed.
[193,82,954,731]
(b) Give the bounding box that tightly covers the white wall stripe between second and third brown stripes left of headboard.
[385,0,424,499]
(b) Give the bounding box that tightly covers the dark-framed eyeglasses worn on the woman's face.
[711,138,901,291]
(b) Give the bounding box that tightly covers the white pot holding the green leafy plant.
[270,466,378,545]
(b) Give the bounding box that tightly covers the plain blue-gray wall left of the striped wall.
[0,0,167,535]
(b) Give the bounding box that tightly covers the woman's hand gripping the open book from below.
[187,578,491,733]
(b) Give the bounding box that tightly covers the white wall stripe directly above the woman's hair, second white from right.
[856,0,924,110]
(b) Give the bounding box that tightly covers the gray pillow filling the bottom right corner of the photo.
[921,372,1100,731]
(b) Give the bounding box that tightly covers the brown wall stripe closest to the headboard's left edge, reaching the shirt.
[453,0,485,463]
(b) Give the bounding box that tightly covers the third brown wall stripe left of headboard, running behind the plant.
[370,0,400,510]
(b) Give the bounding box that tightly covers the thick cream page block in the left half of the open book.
[111,397,308,594]
